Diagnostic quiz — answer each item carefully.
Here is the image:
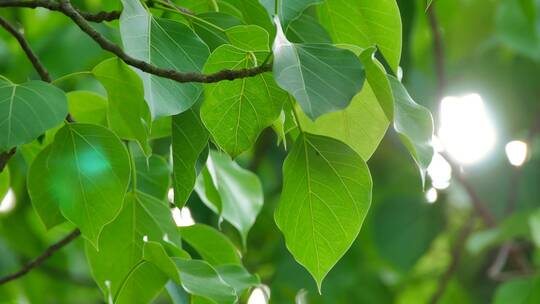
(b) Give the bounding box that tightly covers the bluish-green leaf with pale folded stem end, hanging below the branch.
[272,19,364,120]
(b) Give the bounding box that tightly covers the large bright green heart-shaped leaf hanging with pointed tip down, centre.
[275,133,372,290]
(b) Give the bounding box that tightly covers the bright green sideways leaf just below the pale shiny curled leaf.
[180,224,241,266]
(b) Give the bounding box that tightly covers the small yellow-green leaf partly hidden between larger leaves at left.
[66,91,108,127]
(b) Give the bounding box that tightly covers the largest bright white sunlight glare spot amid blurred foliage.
[439,94,496,165]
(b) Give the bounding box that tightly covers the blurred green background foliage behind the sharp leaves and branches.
[0,0,540,304]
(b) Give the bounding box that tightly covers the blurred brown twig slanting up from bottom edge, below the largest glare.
[429,216,474,304]
